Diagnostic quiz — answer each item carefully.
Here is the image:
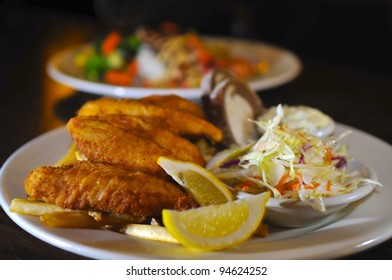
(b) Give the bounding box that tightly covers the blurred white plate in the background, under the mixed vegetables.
[47,37,301,99]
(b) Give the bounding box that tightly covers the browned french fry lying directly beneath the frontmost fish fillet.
[40,210,146,229]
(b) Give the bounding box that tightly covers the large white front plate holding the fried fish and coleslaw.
[0,124,392,259]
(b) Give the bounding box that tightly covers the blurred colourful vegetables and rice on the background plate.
[75,24,268,88]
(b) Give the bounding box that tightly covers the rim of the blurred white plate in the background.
[46,35,302,100]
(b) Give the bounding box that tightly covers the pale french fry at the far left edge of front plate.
[10,198,70,216]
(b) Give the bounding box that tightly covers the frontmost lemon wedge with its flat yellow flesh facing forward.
[162,192,270,251]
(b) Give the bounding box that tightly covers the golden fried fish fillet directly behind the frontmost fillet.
[67,117,175,176]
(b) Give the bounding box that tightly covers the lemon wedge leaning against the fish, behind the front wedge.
[157,157,233,206]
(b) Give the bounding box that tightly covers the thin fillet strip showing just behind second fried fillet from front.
[77,114,206,166]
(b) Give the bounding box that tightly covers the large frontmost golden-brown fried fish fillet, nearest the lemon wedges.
[24,161,197,216]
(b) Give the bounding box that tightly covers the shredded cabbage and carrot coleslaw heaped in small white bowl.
[208,105,380,211]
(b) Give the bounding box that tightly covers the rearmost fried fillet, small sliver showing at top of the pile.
[140,94,205,119]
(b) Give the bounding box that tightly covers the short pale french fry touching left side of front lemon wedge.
[120,224,179,244]
